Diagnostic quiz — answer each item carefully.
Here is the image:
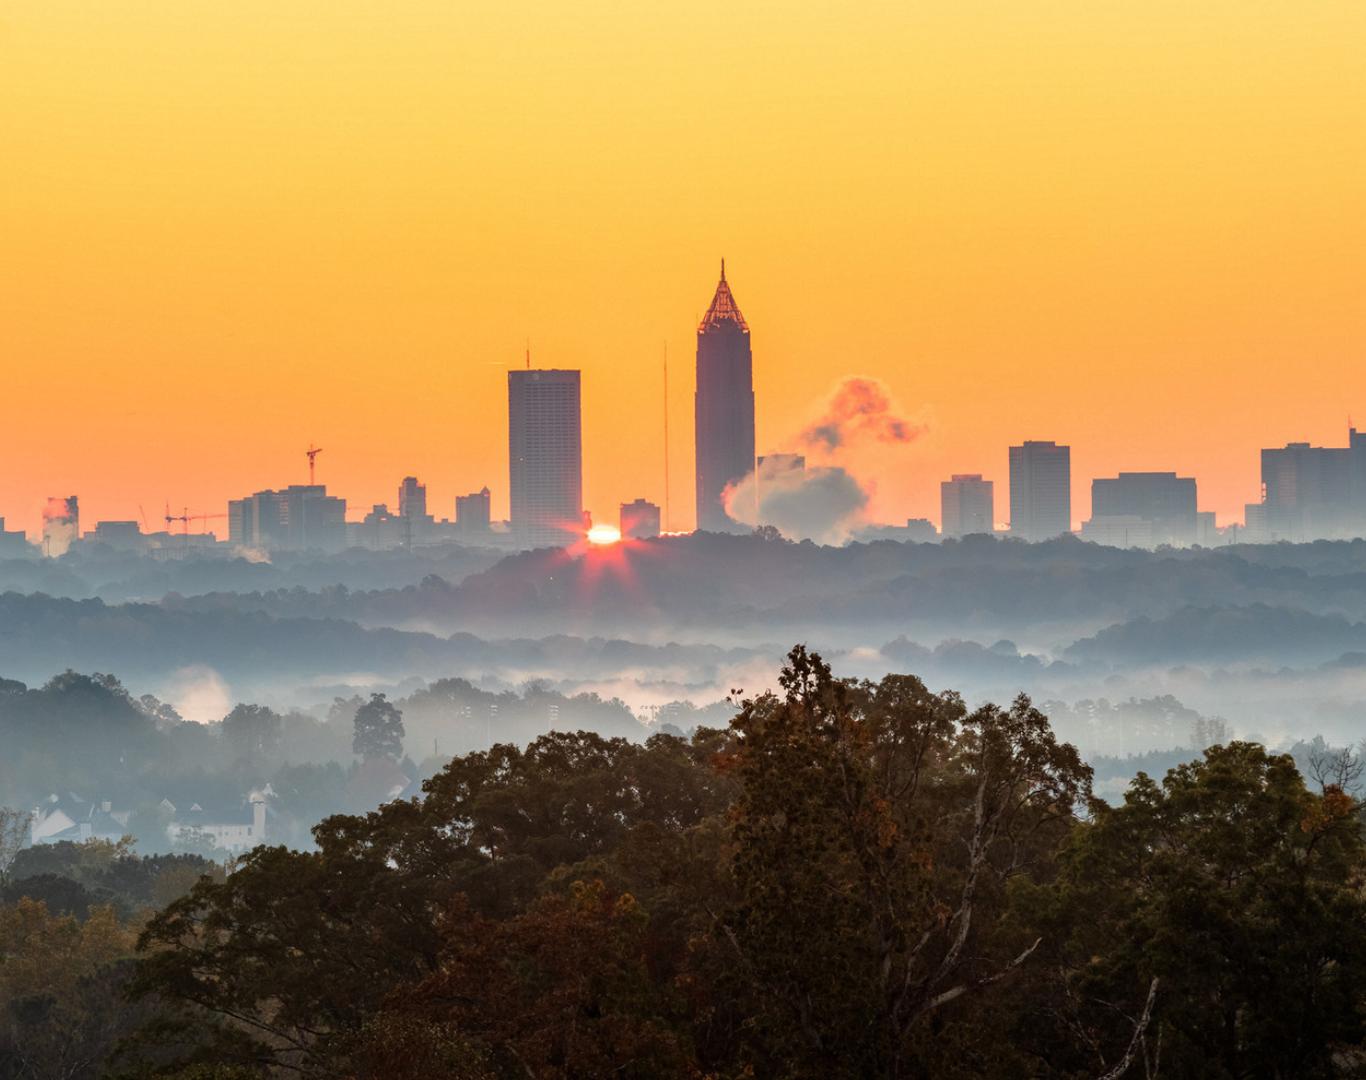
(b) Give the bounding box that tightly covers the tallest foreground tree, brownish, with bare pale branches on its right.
[717,647,1090,1077]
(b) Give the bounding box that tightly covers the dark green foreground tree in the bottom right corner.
[1016,743,1366,1080]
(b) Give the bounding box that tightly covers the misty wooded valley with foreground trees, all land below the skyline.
[0,530,1366,1080]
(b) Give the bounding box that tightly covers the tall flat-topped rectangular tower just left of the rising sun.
[508,370,585,545]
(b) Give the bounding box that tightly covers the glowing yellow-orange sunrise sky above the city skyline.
[0,0,1366,530]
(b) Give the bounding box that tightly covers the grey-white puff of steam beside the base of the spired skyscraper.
[721,459,867,543]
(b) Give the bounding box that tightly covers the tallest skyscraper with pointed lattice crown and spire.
[694,259,754,532]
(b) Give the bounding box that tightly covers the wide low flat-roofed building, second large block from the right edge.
[1082,472,1199,548]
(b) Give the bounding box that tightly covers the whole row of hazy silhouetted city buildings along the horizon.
[0,258,1366,553]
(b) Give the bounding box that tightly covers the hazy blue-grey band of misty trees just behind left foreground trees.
[0,672,704,851]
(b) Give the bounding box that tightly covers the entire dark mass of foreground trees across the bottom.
[0,647,1366,1080]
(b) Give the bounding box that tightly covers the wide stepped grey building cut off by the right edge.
[1259,427,1366,543]
